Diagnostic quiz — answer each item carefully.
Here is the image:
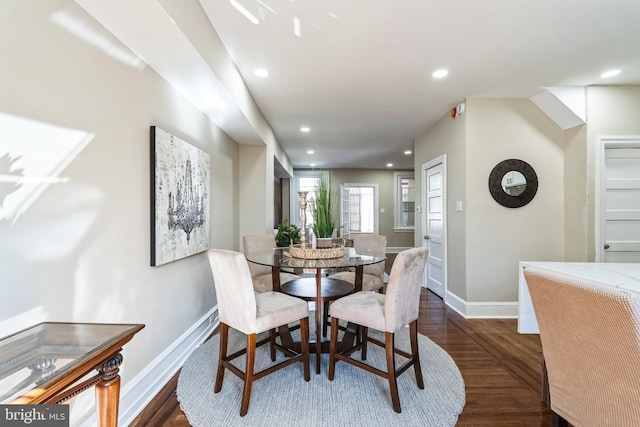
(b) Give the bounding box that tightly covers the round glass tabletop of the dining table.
[245,248,387,269]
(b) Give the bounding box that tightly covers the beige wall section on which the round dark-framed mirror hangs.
[464,99,564,302]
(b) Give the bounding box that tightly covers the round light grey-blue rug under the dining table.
[176,322,465,427]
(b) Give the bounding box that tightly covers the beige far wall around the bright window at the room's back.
[324,169,413,247]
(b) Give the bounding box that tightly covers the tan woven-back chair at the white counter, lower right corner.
[524,267,640,426]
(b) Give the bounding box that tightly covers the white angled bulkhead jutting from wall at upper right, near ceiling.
[529,86,586,130]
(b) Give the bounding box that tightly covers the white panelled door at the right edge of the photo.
[598,139,640,262]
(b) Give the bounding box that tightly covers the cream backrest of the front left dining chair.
[208,249,257,334]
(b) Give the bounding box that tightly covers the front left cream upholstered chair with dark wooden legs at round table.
[208,249,310,416]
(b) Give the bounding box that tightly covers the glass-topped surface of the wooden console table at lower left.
[0,322,144,403]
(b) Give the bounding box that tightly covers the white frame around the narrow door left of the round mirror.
[418,154,449,294]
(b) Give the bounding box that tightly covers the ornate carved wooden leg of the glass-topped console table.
[96,353,122,427]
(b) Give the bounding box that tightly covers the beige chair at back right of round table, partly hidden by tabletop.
[331,234,387,291]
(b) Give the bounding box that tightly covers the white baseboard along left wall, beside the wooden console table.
[80,306,219,427]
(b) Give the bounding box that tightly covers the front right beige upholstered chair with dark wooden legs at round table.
[329,248,427,412]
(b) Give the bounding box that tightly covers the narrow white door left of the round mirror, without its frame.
[422,156,447,298]
